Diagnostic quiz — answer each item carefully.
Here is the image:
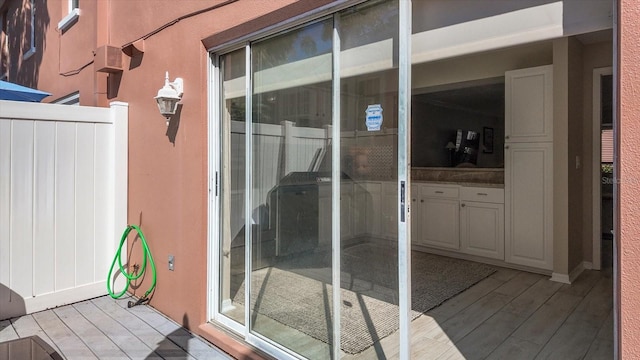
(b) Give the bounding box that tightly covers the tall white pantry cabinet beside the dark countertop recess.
[504,65,553,270]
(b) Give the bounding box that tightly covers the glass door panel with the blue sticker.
[338,1,400,359]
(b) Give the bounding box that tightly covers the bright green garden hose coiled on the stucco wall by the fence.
[107,225,156,307]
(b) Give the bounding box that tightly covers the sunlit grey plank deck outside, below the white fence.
[0,297,231,360]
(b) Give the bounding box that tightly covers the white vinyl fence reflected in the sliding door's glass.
[230,121,397,236]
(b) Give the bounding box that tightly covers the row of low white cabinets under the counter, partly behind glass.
[319,181,505,260]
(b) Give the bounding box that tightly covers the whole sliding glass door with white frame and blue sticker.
[213,1,409,359]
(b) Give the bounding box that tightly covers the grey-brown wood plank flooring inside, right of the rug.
[352,269,613,360]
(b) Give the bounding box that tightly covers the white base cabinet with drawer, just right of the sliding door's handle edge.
[413,185,460,250]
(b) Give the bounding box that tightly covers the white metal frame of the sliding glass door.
[206,0,412,359]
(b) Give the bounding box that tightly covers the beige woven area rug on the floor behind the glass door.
[234,244,495,354]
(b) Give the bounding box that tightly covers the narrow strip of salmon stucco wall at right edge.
[617,0,640,359]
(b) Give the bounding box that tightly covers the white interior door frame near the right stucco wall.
[591,66,613,270]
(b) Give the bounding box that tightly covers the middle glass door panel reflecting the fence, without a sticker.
[249,19,333,359]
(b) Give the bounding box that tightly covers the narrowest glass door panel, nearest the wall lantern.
[218,49,246,324]
